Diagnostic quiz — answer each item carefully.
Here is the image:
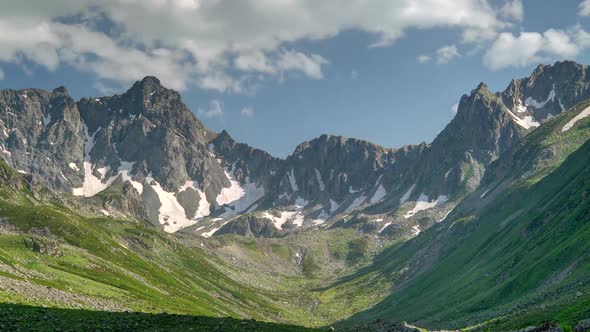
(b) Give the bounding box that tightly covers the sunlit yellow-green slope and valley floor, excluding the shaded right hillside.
[0,160,388,326]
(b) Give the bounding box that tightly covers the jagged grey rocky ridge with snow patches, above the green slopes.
[0,62,590,235]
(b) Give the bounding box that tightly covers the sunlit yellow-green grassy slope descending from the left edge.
[0,164,328,328]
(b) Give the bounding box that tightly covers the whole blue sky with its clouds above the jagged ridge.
[0,0,590,157]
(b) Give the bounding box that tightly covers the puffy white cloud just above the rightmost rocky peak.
[483,27,590,70]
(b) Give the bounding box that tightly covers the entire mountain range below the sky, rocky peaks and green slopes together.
[0,61,590,330]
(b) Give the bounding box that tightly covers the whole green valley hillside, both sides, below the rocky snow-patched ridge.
[0,103,590,331]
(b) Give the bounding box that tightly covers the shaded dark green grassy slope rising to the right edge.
[338,105,590,330]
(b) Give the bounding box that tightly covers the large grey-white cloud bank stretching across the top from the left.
[0,0,505,92]
